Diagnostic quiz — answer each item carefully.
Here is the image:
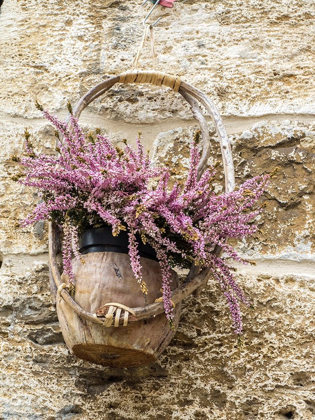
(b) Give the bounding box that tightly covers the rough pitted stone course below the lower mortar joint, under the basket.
[0,263,315,420]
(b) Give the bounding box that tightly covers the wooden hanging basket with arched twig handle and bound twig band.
[49,72,235,367]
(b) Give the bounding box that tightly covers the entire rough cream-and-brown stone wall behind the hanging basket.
[0,0,315,420]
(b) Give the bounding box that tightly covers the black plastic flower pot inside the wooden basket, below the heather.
[80,226,157,260]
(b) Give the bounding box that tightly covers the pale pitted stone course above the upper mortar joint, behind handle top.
[0,0,315,122]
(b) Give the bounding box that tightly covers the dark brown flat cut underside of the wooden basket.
[72,344,156,368]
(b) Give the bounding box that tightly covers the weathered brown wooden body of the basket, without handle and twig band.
[57,252,181,367]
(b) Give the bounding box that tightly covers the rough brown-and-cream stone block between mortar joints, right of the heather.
[153,120,315,260]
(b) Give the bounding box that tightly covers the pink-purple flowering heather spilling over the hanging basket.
[21,110,268,334]
